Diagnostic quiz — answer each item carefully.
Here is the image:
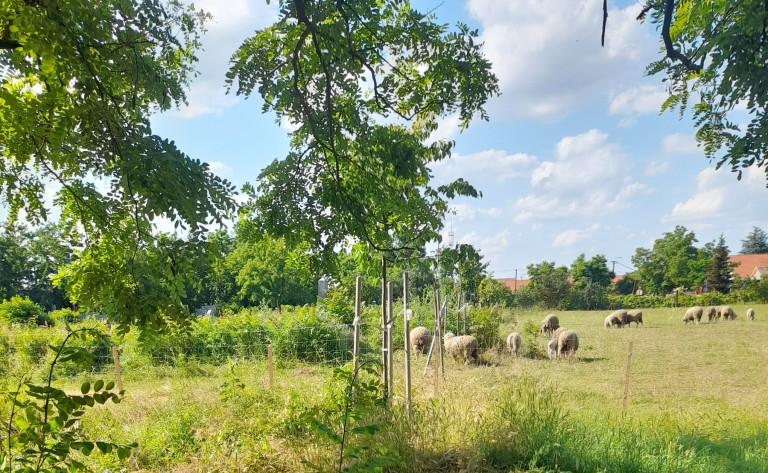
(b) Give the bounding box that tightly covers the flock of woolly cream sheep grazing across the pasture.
[408,305,755,365]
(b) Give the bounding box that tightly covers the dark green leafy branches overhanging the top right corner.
[638,0,768,185]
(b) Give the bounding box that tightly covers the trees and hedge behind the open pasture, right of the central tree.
[479,226,768,310]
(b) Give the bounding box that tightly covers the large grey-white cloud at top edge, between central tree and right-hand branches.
[467,0,656,117]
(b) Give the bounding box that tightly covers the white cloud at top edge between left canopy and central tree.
[175,0,277,118]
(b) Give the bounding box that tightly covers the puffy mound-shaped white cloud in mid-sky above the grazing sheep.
[513,130,645,223]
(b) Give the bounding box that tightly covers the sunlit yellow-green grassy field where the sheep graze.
[27,306,768,473]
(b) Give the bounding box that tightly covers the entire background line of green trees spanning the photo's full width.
[0,224,768,324]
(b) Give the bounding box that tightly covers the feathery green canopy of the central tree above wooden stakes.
[228,0,499,272]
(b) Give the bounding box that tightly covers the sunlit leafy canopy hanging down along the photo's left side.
[0,0,234,329]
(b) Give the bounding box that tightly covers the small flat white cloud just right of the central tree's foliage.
[432,149,536,185]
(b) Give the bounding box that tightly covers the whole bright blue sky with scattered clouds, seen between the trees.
[153,0,768,277]
